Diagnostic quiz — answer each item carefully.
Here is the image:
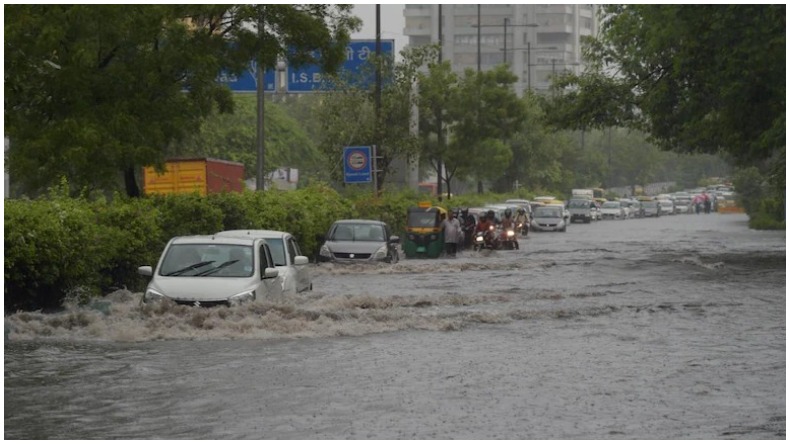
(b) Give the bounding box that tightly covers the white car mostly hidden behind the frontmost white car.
[216,230,313,294]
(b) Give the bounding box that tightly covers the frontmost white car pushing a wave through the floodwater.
[137,236,282,306]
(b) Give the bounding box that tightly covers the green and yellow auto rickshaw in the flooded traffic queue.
[403,202,447,259]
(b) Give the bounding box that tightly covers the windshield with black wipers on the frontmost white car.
[159,244,254,277]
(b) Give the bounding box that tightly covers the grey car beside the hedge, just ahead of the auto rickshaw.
[318,219,400,264]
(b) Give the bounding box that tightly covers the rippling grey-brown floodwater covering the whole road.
[4,214,786,440]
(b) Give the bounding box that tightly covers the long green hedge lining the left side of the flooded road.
[4,183,544,310]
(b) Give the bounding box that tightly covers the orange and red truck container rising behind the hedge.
[143,158,244,196]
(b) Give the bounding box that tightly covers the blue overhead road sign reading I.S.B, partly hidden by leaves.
[286,40,395,93]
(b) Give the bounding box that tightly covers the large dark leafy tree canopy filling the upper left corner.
[5,4,359,196]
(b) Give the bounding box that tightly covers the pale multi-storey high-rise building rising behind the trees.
[403,4,598,95]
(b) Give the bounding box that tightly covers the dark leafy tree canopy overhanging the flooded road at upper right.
[554,5,786,180]
